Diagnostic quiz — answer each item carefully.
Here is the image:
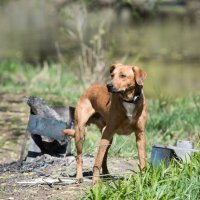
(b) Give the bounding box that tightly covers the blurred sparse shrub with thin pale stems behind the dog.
[59,4,112,88]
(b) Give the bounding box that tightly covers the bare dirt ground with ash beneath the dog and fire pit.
[0,94,137,200]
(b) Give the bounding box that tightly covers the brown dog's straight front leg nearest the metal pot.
[135,131,146,170]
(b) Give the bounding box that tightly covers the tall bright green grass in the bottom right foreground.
[84,154,200,200]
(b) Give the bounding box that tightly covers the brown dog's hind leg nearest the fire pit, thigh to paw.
[75,101,95,183]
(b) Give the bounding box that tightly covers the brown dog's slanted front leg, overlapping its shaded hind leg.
[92,130,114,185]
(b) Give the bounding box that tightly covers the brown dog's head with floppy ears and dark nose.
[107,64,147,93]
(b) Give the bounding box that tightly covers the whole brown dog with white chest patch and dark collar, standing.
[63,64,147,184]
